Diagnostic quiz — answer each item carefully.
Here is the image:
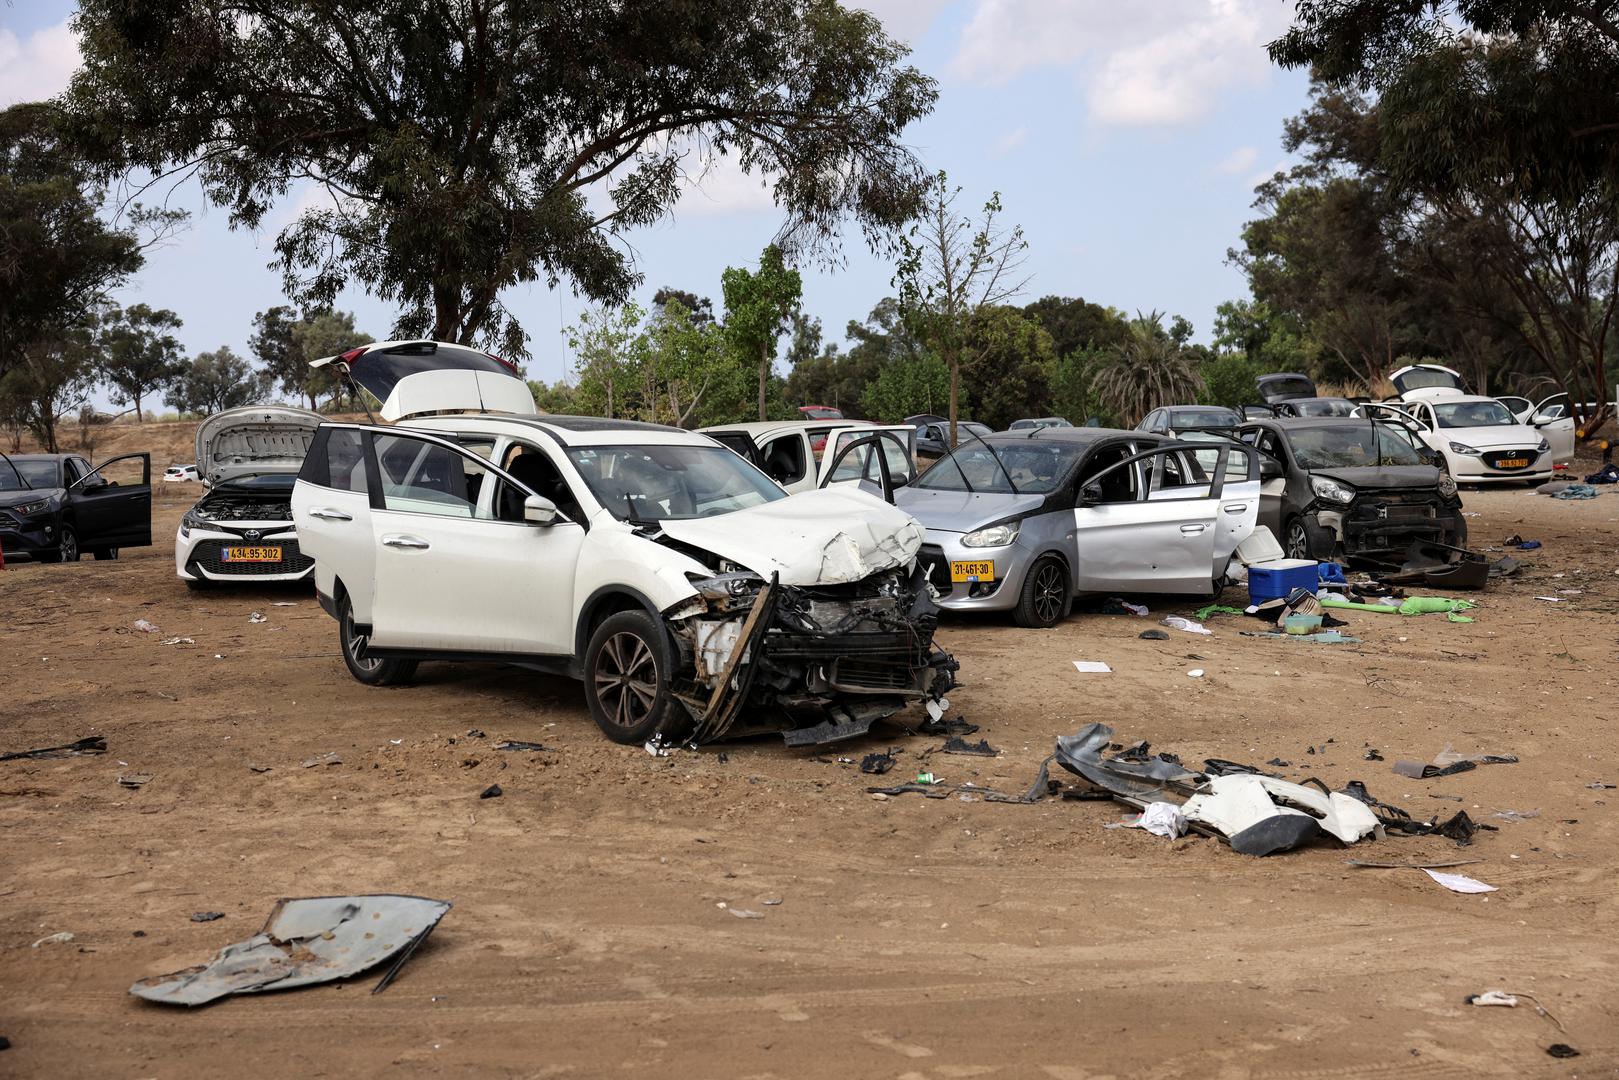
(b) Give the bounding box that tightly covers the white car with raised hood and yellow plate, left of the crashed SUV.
[175,405,321,589]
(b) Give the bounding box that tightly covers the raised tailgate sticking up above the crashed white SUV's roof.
[309,342,539,421]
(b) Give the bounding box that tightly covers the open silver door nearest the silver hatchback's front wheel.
[1073,450,1217,593]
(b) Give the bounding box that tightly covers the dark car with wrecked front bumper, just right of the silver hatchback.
[1240,416,1467,563]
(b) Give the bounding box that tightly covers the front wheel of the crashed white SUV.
[584,610,683,745]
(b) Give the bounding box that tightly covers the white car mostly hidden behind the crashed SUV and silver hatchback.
[701,419,916,492]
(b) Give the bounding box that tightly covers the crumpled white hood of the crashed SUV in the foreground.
[662,487,923,586]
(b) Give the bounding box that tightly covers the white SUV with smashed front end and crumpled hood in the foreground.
[293,347,955,745]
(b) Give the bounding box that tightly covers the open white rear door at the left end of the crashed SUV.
[293,424,376,623]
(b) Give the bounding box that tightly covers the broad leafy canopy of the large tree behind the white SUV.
[65,0,937,358]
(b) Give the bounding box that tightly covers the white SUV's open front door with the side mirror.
[371,429,586,656]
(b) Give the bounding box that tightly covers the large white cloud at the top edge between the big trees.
[952,0,1292,126]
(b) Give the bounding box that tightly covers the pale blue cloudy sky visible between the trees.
[0,0,1307,393]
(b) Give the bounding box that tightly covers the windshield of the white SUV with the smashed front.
[568,445,787,523]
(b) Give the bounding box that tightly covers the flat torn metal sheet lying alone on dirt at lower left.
[130,894,450,1006]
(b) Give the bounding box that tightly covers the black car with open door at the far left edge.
[0,453,152,562]
